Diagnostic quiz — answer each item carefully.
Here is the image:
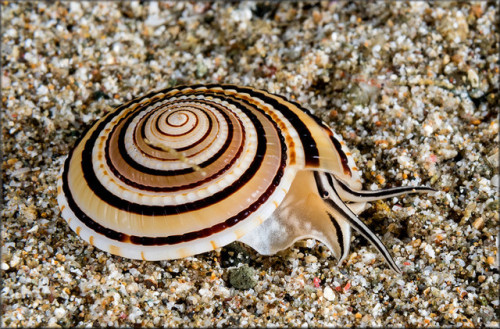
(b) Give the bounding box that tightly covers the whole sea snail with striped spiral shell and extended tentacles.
[57,84,434,272]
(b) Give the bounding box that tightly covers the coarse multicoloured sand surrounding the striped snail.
[1,1,499,327]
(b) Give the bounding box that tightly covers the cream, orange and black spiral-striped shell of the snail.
[58,85,352,260]
